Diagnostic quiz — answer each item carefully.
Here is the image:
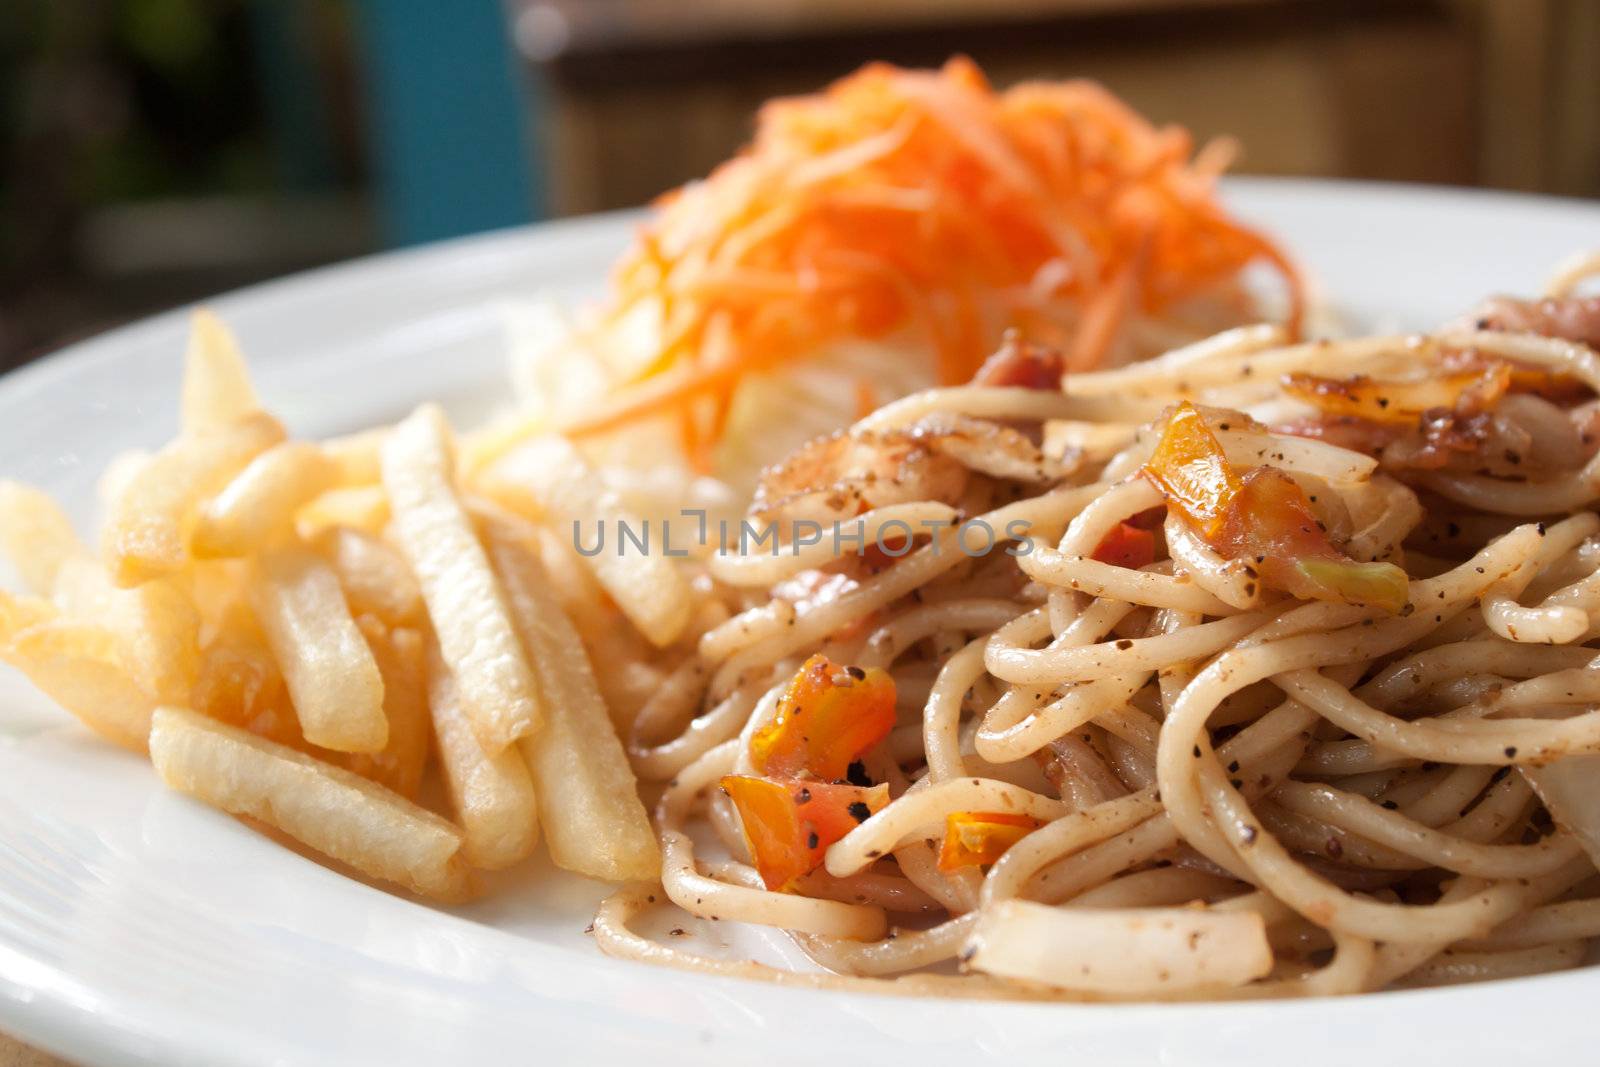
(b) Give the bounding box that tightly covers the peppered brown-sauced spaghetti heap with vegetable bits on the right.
[595,258,1600,1000]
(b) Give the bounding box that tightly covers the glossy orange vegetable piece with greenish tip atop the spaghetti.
[1144,403,1410,611]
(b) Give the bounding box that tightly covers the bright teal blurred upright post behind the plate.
[348,0,542,245]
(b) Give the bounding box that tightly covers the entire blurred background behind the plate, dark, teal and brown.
[0,0,1600,370]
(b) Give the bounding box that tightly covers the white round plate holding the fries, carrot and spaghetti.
[0,181,1600,1067]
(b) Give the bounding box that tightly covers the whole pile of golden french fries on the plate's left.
[0,310,693,902]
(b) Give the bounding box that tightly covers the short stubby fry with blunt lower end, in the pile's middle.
[251,549,389,752]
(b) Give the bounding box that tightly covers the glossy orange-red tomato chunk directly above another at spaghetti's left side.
[750,654,894,782]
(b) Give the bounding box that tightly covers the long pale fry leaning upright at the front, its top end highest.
[382,405,542,755]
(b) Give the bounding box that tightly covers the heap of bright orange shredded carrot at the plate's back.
[568,59,1302,456]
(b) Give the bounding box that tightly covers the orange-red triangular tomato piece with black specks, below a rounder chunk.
[722,774,890,891]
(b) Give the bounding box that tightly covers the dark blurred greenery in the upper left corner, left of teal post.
[0,0,365,370]
